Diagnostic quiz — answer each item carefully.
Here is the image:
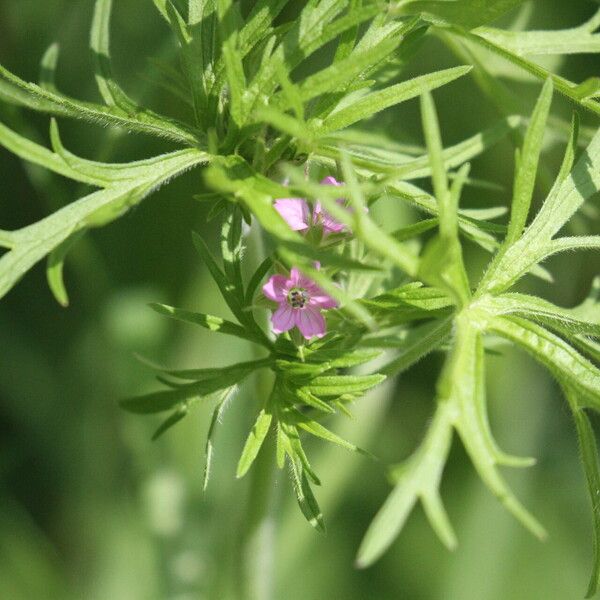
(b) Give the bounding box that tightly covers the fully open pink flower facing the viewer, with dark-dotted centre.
[263,267,337,340]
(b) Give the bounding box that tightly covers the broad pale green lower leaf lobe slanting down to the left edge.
[0,149,208,297]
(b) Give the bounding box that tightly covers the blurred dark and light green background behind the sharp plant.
[0,0,600,600]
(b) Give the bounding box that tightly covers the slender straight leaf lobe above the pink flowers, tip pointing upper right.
[315,66,471,136]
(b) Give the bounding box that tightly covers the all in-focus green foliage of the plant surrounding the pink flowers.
[0,0,600,595]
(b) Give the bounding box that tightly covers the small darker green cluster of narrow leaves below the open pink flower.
[121,206,385,530]
